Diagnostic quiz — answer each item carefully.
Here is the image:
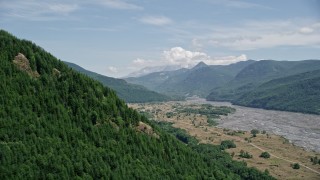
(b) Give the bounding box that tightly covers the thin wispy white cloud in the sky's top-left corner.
[0,0,143,21]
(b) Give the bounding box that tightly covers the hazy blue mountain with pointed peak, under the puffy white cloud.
[126,61,254,97]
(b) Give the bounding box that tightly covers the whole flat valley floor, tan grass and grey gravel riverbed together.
[130,99,320,179]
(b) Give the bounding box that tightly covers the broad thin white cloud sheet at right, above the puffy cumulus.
[195,21,320,51]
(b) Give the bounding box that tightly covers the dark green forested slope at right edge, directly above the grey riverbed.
[233,69,320,114]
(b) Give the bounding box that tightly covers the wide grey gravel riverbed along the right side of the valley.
[188,98,320,152]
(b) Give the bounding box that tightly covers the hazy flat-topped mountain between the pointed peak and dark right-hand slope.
[207,60,320,101]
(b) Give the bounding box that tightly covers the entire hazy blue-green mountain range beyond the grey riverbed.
[126,57,320,114]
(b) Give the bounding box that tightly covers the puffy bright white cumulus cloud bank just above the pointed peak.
[108,47,248,77]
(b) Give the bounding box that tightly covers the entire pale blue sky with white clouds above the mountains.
[0,0,320,77]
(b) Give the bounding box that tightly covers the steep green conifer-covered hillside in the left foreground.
[0,30,274,179]
